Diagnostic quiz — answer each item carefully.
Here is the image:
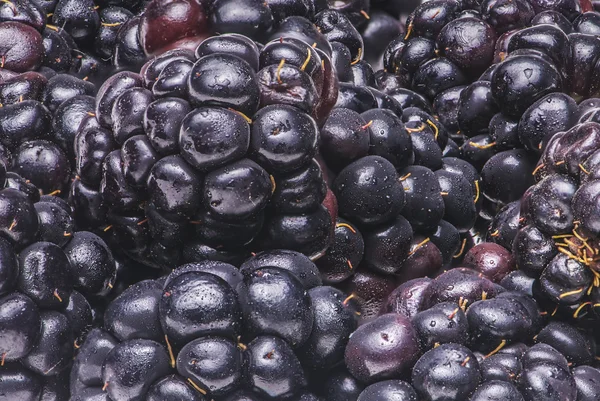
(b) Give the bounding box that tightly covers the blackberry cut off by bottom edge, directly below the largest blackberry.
[70,251,358,401]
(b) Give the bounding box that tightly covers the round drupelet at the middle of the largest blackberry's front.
[179,107,250,171]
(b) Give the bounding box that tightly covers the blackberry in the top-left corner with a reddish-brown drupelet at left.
[0,0,157,82]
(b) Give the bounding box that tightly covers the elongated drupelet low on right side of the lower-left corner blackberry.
[23,311,74,376]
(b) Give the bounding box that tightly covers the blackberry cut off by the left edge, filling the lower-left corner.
[0,182,116,401]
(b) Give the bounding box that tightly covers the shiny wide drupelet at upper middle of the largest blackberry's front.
[188,54,260,115]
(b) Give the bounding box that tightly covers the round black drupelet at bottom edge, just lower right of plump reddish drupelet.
[412,343,480,401]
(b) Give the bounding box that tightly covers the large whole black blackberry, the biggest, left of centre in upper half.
[70,25,336,268]
